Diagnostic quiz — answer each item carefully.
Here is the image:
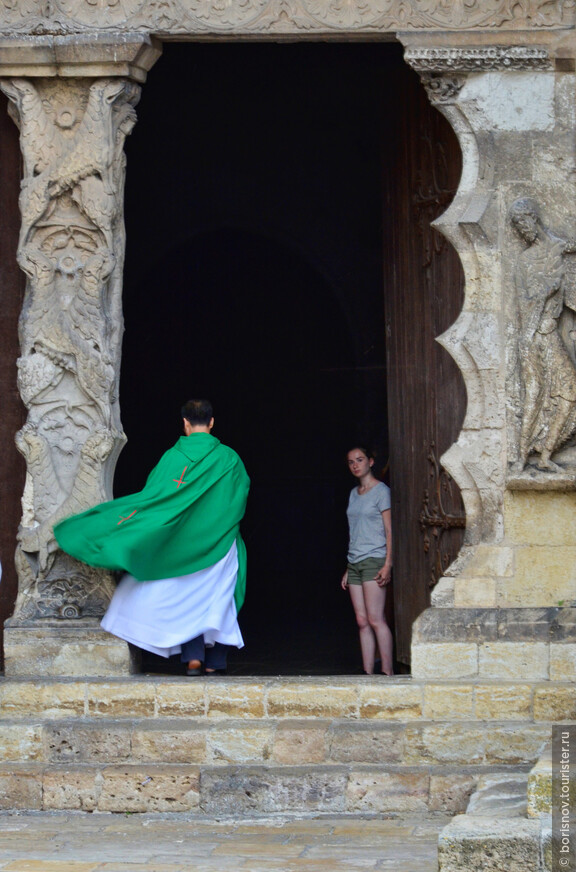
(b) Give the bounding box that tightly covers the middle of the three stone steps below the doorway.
[0,718,549,769]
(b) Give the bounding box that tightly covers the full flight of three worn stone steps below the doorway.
[0,675,576,816]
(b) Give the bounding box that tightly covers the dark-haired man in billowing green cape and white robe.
[54,400,250,675]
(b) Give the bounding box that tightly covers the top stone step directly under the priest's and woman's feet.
[0,675,576,724]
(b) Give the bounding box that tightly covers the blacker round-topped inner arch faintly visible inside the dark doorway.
[117,229,385,672]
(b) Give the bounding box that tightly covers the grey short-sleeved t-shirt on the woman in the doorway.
[346,482,391,563]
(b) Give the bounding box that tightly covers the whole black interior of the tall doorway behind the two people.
[115,43,404,674]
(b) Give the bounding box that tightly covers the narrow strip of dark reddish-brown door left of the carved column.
[0,93,26,668]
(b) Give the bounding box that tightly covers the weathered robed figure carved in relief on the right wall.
[510,198,576,472]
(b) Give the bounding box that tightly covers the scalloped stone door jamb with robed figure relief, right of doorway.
[401,32,576,679]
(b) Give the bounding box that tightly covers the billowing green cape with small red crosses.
[54,433,250,610]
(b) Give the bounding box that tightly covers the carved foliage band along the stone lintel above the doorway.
[0,0,576,35]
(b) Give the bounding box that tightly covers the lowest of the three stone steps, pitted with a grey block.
[0,761,520,817]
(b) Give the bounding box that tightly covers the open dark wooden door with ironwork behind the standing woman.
[383,65,466,665]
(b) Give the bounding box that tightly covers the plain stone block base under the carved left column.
[4,619,139,678]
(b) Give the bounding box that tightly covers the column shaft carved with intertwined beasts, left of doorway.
[0,79,139,619]
